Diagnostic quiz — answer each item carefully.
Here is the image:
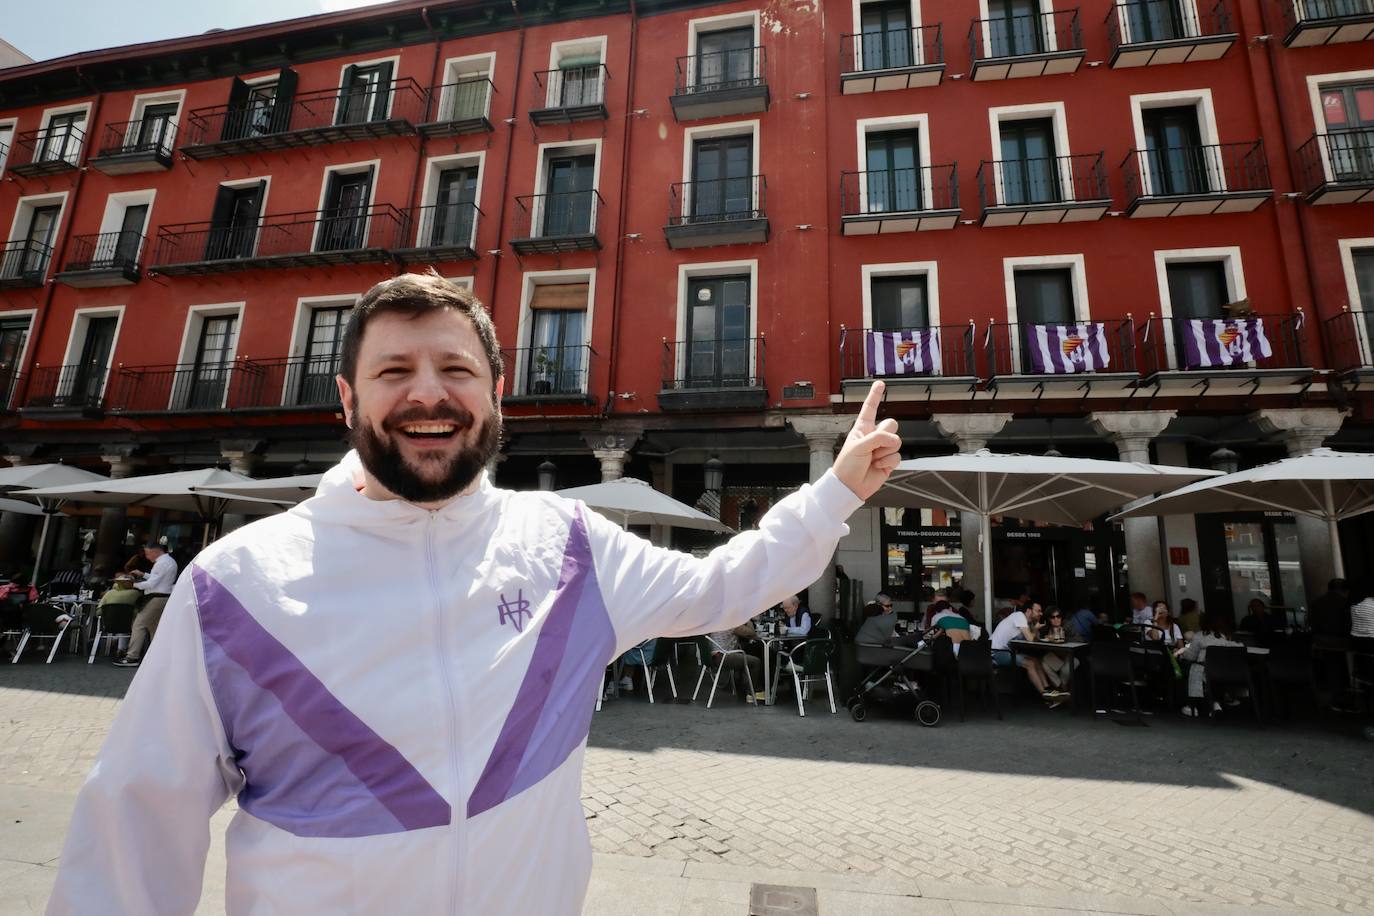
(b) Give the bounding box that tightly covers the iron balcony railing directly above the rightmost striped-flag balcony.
[1121,140,1272,201]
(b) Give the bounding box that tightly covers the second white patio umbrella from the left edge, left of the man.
[15,467,292,554]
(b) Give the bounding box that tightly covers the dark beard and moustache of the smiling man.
[349,404,502,503]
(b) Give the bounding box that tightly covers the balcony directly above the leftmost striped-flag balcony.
[840,165,963,235]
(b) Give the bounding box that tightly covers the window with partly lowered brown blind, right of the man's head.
[525,280,591,394]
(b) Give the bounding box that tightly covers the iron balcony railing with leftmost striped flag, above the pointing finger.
[840,321,978,379]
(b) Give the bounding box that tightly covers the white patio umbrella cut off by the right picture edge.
[1114,449,1374,578]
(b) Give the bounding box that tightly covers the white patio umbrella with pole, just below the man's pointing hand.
[868,449,1216,628]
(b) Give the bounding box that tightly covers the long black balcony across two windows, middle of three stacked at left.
[148,203,401,276]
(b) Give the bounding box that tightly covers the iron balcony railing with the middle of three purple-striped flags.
[984,319,1139,378]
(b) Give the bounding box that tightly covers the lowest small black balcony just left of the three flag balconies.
[658,336,768,411]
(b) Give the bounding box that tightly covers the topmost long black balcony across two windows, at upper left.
[181,78,426,159]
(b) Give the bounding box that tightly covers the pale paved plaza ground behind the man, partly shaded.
[0,659,1374,916]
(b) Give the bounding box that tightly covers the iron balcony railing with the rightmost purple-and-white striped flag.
[1136,312,1311,376]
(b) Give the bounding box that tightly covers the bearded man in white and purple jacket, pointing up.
[48,275,900,916]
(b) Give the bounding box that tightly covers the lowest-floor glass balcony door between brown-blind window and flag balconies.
[684,276,753,389]
